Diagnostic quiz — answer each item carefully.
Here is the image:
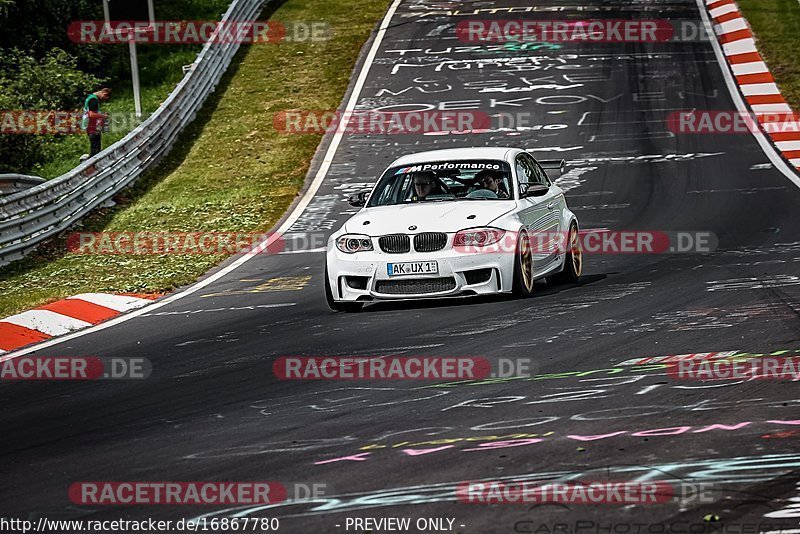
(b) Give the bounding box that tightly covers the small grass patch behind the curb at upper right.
[738,0,800,112]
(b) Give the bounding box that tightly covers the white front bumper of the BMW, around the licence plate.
[327,245,514,302]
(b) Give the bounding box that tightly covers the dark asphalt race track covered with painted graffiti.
[0,0,800,534]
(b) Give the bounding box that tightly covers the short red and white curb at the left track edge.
[0,293,160,354]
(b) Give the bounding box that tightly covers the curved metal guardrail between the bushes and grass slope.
[0,0,264,265]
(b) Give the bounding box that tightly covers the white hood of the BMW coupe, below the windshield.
[345,200,516,236]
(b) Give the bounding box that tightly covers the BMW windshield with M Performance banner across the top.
[368,160,513,207]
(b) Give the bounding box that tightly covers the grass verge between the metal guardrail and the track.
[0,0,387,317]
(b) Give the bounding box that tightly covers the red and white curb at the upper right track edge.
[705,0,800,169]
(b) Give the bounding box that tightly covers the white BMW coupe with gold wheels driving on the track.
[325,148,583,311]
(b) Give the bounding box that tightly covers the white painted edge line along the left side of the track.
[0,0,401,362]
